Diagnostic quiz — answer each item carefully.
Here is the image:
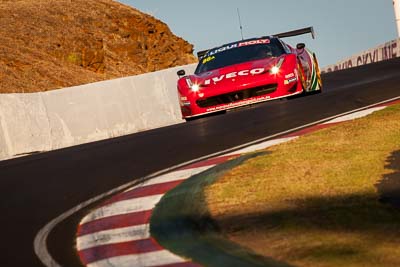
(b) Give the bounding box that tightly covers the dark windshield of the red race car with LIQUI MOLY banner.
[195,39,285,74]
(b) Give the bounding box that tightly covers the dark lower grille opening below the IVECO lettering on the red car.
[196,84,278,108]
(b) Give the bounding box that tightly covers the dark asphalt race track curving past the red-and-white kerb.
[0,59,400,267]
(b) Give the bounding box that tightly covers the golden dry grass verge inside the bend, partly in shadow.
[206,105,400,267]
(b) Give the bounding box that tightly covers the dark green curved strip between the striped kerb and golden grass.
[150,154,290,267]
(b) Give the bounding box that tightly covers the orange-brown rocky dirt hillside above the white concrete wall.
[0,0,195,93]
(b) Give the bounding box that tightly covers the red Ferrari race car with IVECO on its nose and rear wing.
[178,27,322,119]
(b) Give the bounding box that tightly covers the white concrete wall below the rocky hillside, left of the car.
[0,64,195,160]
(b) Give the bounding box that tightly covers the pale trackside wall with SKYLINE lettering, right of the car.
[321,39,400,73]
